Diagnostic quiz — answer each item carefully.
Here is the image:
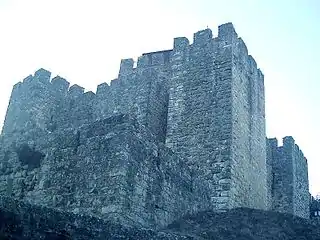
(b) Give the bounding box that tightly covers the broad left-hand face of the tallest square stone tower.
[166,29,232,209]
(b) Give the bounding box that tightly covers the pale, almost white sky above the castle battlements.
[0,0,320,195]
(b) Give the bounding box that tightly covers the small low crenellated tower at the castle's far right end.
[267,136,310,218]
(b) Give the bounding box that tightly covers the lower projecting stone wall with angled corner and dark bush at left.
[0,115,208,227]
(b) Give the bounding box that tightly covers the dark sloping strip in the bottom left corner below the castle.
[0,197,190,240]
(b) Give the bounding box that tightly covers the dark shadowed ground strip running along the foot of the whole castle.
[0,197,320,240]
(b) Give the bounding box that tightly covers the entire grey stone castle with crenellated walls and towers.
[0,23,310,227]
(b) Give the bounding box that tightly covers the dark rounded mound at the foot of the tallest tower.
[167,208,320,240]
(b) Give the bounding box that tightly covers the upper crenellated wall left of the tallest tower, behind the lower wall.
[2,62,168,142]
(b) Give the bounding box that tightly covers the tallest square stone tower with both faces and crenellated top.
[166,23,268,209]
